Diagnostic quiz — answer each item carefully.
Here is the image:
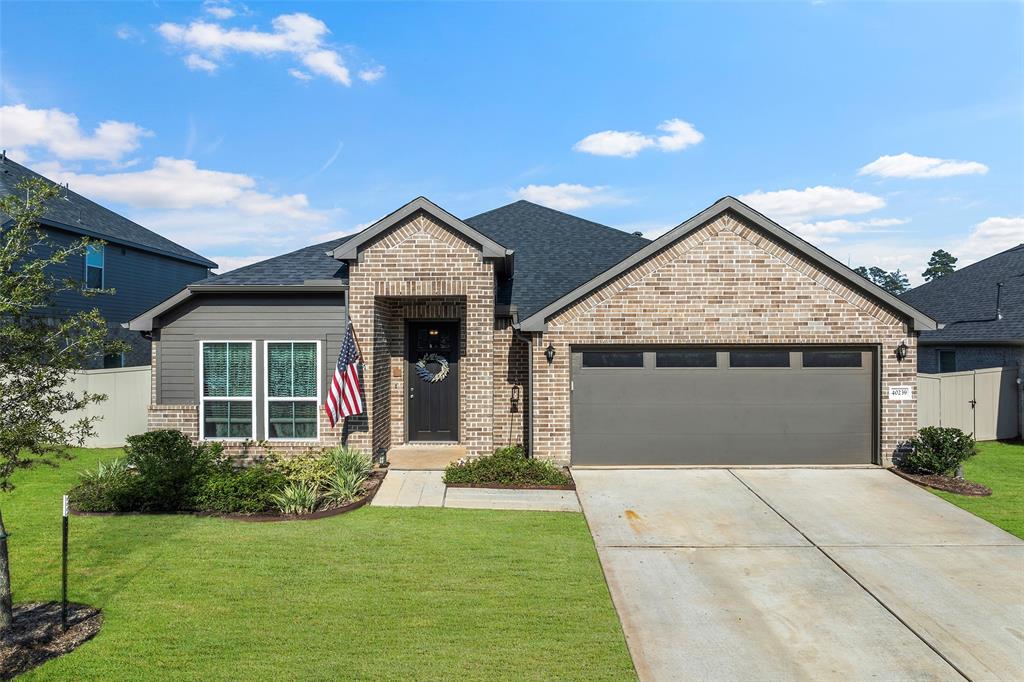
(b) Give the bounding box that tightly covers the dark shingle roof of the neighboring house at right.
[900,244,1024,343]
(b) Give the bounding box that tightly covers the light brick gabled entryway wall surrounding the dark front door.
[349,212,495,455]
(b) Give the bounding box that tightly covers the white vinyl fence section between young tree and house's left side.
[65,365,151,447]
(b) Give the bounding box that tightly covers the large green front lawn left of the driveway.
[0,450,636,680]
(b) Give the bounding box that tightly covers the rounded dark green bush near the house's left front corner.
[125,430,223,512]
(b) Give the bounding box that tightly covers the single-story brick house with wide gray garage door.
[130,193,936,465]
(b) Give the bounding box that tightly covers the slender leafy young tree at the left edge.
[0,178,124,631]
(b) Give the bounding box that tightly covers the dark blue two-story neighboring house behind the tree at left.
[0,154,217,368]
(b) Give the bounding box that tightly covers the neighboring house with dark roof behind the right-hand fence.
[900,244,1024,374]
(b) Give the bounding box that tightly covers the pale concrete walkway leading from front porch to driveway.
[371,469,581,512]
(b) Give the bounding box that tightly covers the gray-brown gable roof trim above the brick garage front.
[520,197,937,332]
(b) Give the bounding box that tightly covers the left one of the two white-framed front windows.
[199,341,256,440]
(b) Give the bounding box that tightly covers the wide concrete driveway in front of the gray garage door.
[572,469,1024,680]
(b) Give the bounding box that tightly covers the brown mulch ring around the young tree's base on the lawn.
[0,601,103,680]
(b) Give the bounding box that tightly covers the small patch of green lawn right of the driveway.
[929,441,1024,538]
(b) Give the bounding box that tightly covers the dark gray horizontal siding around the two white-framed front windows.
[154,291,346,437]
